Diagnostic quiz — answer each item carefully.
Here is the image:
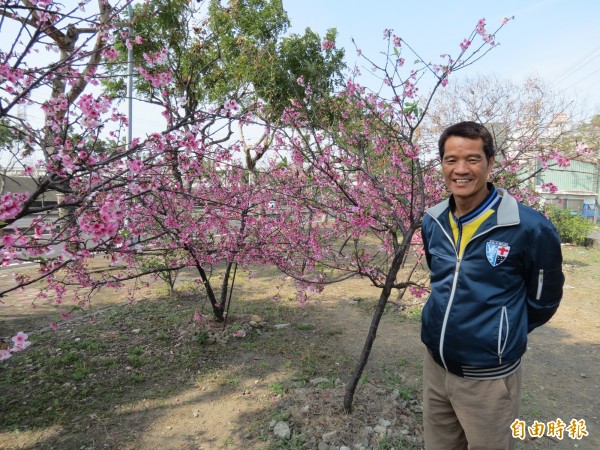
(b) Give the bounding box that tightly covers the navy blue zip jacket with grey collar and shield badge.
[421,189,564,376]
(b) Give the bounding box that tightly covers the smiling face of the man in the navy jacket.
[442,136,494,208]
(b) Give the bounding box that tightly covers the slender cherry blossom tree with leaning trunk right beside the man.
[260,19,506,411]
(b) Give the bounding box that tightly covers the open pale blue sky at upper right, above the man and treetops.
[283,0,600,118]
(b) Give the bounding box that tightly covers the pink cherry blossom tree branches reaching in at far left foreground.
[0,1,247,320]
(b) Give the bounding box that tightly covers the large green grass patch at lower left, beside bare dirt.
[0,292,220,436]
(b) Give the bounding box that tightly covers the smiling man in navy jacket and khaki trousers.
[421,122,564,450]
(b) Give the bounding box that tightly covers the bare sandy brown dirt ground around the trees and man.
[0,247,600,450]
